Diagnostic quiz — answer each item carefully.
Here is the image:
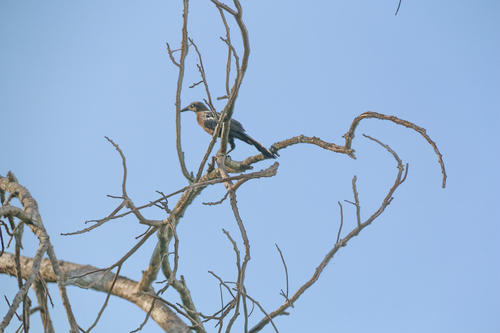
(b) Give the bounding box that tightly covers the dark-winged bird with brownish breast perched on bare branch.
[181,102,278,158]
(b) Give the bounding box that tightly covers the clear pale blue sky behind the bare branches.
[0,0,500,333]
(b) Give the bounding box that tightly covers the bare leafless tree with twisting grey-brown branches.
[0,0,446,332]
